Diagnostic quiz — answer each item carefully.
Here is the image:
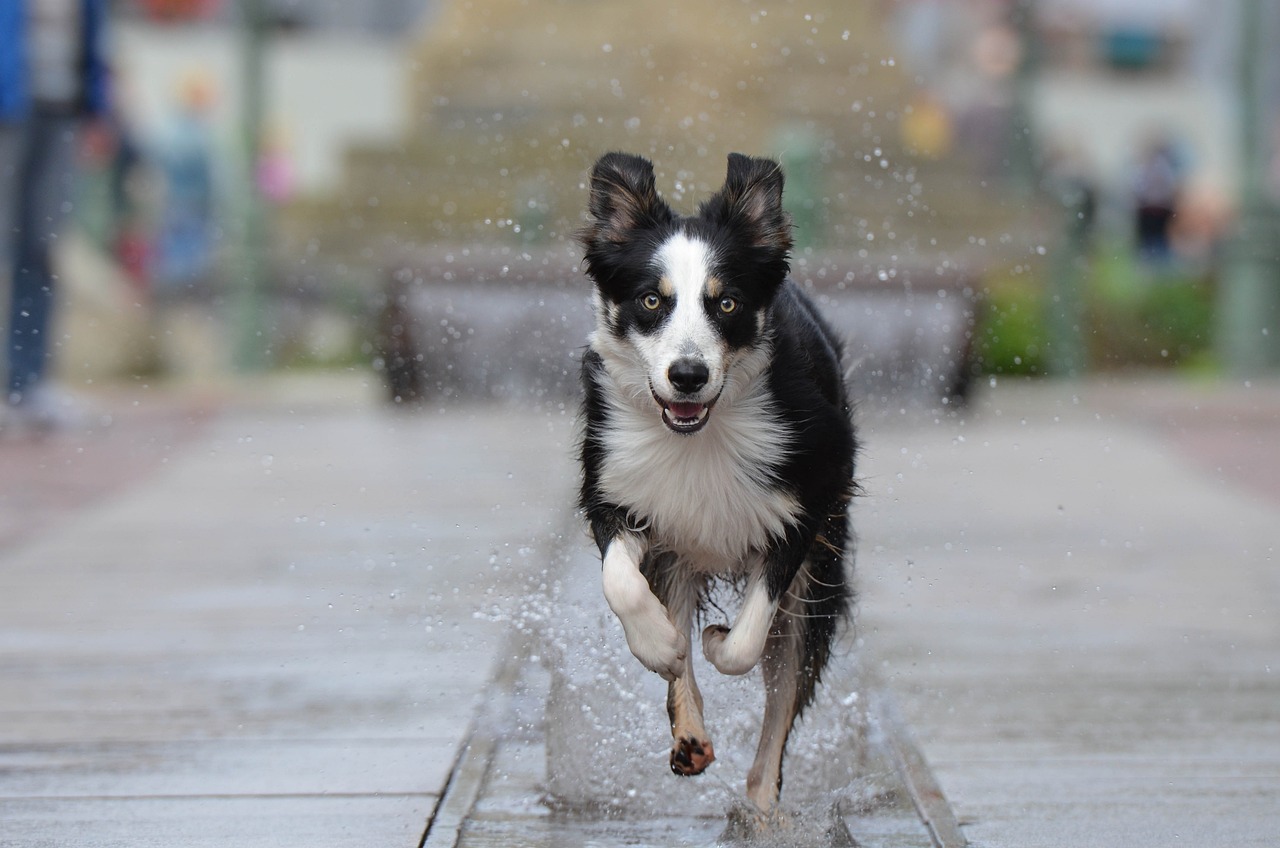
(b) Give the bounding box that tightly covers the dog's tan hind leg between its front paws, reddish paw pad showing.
[646,557,716,778]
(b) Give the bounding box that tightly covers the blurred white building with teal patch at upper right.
[1034,0,1239,208]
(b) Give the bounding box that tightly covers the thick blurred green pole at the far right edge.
[1217,0,1280,374]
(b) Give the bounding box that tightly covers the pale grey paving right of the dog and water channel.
[859,379,1280,848]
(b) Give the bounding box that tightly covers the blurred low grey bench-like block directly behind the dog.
[375,247,978,409]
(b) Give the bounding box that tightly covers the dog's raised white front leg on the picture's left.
[603,533,689,680]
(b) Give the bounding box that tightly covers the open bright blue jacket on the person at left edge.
[0,0,108,122]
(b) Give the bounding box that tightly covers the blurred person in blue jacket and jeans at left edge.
[0,0,108,429]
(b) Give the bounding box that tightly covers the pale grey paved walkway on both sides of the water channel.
[0,380,1280,848]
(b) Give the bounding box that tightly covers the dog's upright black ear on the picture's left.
[580,152,672,247]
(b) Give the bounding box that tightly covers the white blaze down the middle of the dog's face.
[634,233,726,402]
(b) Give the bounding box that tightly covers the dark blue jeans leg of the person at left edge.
[8,115,76,404]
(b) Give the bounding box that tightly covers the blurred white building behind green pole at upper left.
[113,0,431,195]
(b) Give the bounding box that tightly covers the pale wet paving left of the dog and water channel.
[0,380,571,848]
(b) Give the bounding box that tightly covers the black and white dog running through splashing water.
[580,154,856,812]
